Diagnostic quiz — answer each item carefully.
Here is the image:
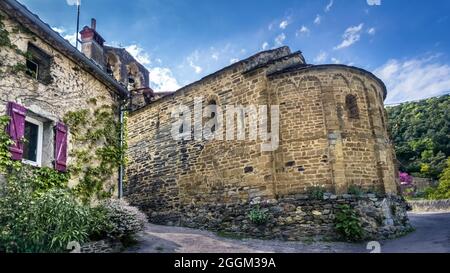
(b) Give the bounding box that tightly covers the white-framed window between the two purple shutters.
[23,116,44,167]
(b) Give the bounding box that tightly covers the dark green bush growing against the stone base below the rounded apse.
[335,205,364,242]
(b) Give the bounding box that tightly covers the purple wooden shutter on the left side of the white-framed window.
[7,102,27,160]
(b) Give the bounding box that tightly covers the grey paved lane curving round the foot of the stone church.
[127,213,450,253]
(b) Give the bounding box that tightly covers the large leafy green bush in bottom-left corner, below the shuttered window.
[0,177,89,253]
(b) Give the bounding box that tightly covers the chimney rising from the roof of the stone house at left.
[80,18,105,67]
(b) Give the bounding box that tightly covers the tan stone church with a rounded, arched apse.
[126,47,407,238]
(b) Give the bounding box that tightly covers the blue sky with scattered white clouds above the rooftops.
[16,0,450,103]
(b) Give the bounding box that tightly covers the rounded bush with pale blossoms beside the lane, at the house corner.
[93,199,147,239]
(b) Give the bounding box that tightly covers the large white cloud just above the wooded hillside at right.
[374,55,450,103]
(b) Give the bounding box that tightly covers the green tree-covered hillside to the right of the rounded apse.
[387,95,450,180]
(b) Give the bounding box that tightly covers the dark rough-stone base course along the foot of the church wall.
[146,194,411,240]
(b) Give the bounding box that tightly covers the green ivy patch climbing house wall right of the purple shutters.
[64,99,126,203]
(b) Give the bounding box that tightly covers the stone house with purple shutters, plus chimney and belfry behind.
[0,0,152,196]
